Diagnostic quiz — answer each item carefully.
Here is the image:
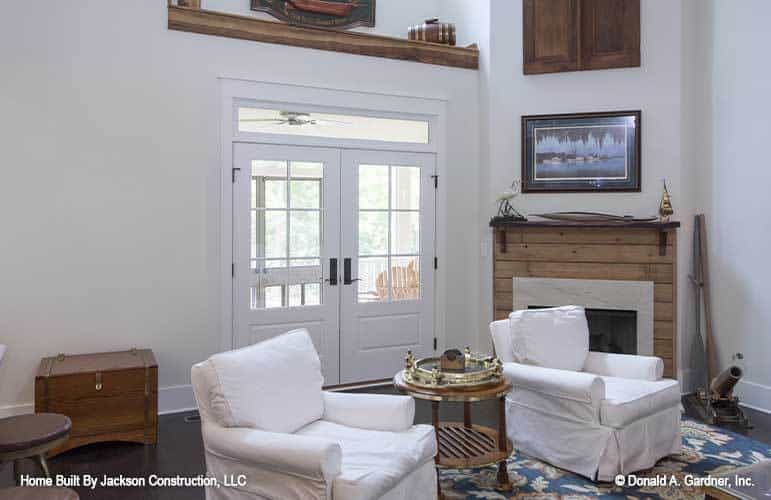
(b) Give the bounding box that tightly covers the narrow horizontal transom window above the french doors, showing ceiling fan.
[238,106,429,144]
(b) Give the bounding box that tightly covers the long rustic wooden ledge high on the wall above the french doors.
[168,5,479,69]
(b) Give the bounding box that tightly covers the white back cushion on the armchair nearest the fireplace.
[509,306,589,371]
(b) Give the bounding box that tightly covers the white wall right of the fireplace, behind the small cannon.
[706,0,771,411]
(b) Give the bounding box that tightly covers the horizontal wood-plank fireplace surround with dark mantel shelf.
[491,220,680,378]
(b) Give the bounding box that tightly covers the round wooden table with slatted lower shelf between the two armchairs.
[394,370,512,498]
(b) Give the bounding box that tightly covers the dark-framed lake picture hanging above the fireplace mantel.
[522,110,642,193]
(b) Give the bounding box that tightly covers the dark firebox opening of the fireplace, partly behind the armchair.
[528,306,637,354]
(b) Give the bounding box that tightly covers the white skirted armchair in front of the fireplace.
[490,306,681,481]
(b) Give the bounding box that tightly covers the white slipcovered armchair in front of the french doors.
[192,330,437,500]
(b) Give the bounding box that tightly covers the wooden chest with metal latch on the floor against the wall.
[35,349,158,455]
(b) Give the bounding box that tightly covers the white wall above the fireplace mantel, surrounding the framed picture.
[478,0,688,376]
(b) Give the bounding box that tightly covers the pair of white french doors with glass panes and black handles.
[233,143,435,385]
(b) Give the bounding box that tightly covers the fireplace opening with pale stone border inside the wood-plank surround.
[513,278,653,356]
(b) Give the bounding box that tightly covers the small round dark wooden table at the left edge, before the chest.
[0,413,72,485]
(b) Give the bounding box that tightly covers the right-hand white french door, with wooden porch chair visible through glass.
[340,151,435,383]
